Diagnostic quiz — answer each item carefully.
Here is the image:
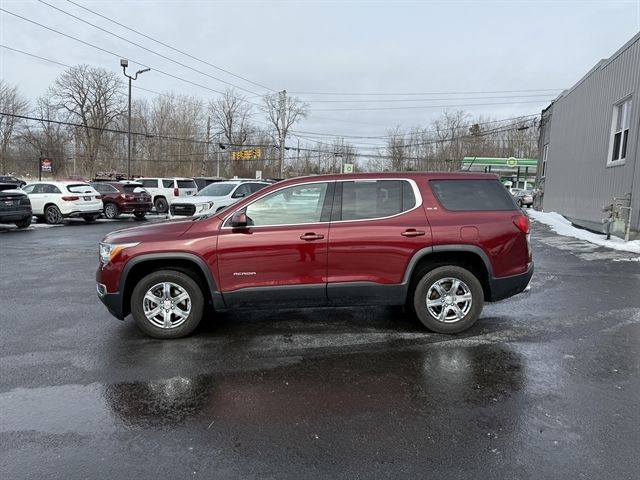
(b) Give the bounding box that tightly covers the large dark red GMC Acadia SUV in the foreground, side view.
[97,172,533,338]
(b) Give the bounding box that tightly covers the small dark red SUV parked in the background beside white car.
[91,182,153,219]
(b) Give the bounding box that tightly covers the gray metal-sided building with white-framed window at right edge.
[537,33,640,239]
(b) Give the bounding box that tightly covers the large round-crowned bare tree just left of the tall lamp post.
[49,65,126,176]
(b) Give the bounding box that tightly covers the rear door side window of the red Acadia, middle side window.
[341,180,416,220]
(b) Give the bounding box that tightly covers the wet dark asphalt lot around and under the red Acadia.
[0,219,640,480]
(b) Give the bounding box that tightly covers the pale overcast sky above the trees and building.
[0,0,640,149]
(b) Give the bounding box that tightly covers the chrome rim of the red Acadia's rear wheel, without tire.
[427,278,473,323]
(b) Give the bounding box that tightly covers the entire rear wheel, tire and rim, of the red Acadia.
[412,265,484,333]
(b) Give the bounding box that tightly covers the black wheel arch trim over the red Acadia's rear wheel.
[403,245,493,301]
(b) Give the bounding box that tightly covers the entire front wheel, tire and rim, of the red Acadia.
[131,270,204,338]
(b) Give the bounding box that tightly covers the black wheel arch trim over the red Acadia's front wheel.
[121,252,224,316]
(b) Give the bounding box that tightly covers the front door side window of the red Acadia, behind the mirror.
[246,183,327,226]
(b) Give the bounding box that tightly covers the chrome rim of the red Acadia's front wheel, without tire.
[142,282,191,329]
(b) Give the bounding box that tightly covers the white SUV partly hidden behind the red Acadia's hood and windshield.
[171,180,270,217]
